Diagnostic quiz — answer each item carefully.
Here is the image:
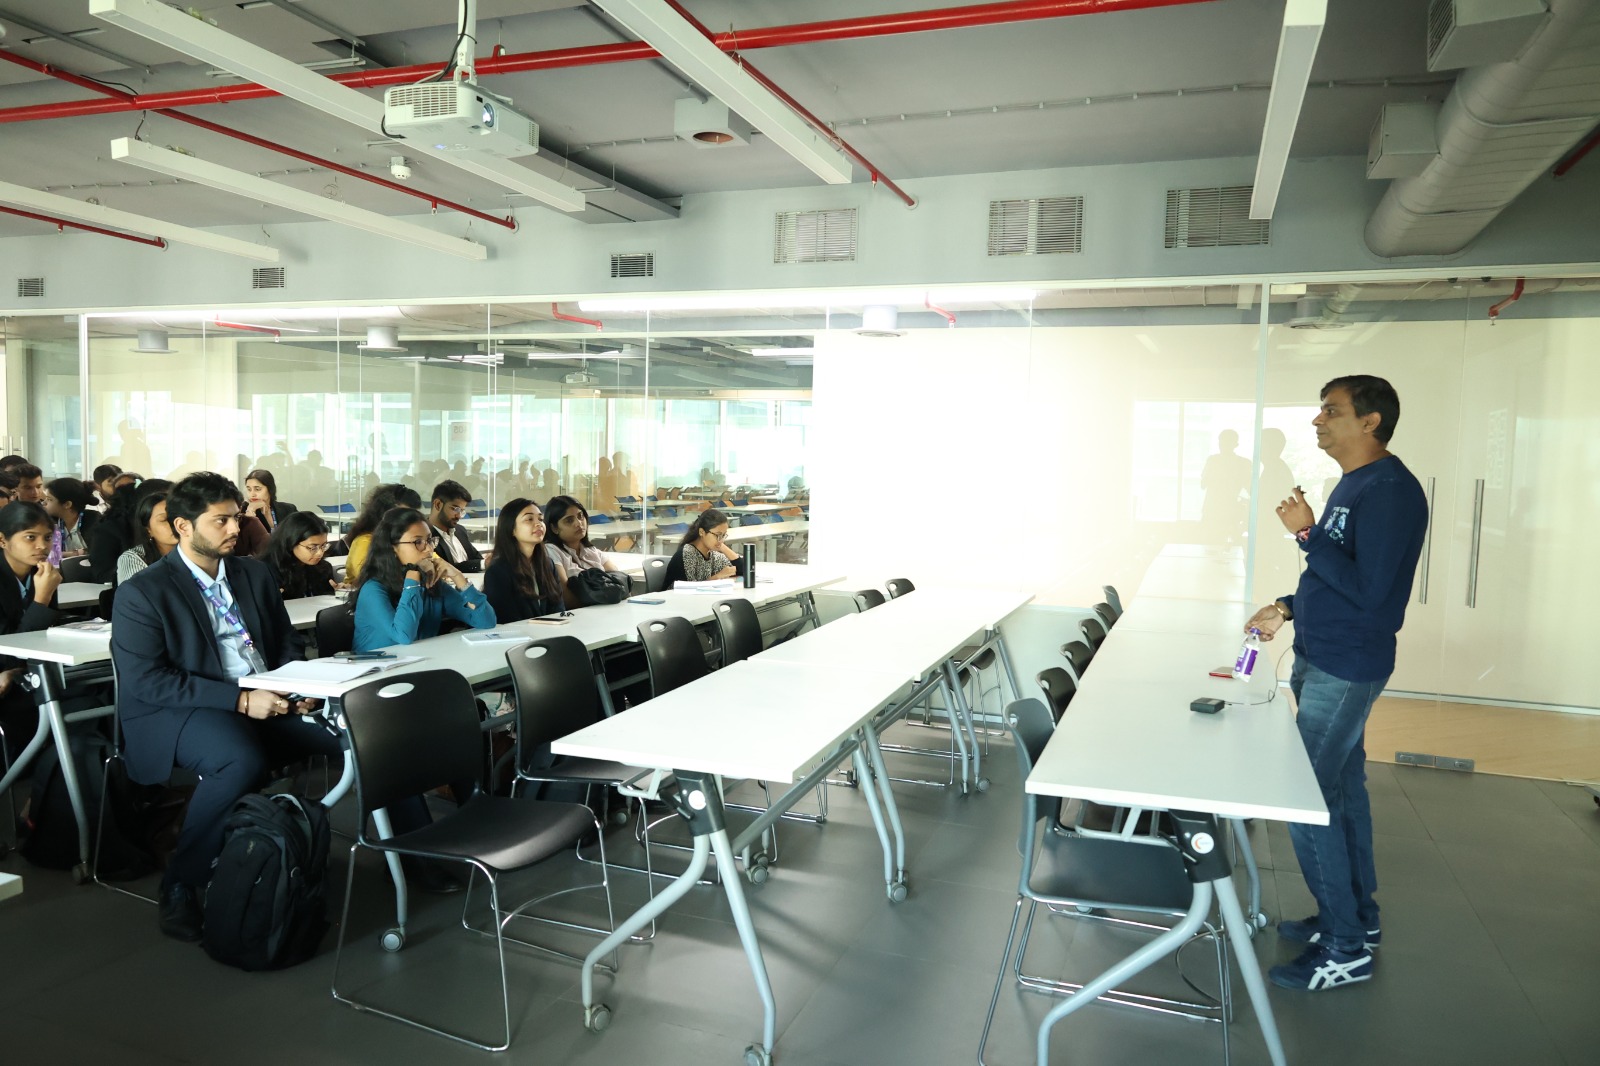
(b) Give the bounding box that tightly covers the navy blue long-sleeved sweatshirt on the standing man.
[1282,455,1427,682]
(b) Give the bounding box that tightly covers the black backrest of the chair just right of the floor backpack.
[344,671,483,826]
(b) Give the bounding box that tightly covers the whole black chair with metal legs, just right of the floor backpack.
[333,669,614,1052]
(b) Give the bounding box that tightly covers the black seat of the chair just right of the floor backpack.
[371,792,595,871]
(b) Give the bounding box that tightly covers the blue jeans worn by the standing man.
[1290,656,1389,951]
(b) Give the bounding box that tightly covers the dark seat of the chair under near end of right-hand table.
[1027,832,1194,912]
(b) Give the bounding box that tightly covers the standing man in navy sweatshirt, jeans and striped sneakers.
[1246,375,1427,992]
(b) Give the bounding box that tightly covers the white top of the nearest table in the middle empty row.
[550,661,906,784]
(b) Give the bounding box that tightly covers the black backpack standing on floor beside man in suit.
[202,794,328,970]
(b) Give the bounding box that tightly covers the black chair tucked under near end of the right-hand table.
[978,699,1230,1064]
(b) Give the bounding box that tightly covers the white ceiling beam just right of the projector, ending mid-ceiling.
[595,0,851,186]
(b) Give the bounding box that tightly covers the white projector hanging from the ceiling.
[384,82,539,158]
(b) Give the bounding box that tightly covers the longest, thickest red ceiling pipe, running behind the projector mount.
[0,0,1216,122]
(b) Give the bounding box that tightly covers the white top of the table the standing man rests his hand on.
[1027,603,1328,824]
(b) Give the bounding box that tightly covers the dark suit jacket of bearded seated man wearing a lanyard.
[111,549,306,784]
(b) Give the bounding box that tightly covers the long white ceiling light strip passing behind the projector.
[90,0,587,211]
